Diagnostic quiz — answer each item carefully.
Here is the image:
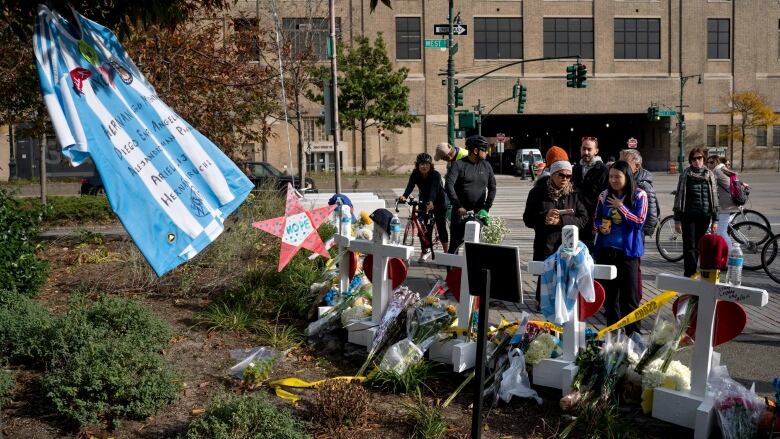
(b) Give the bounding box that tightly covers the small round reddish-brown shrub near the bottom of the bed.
[314,379,369,429]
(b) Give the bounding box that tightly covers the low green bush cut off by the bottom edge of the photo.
[186,394,310,439]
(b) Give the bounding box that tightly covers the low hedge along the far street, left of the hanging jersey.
[24,196,116,226]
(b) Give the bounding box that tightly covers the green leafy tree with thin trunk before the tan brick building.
[307,33,417,171]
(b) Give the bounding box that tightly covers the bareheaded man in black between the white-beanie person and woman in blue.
[572,136,609,249]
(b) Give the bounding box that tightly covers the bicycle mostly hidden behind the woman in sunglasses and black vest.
[655,191,772,262]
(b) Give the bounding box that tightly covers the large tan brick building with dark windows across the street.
[230,0,780,175]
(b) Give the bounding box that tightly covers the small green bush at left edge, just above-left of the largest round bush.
[0,291,54,363]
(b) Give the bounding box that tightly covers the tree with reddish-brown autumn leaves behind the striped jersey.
[126,19,278,158]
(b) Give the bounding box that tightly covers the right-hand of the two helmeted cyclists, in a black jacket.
[445,136,496,253]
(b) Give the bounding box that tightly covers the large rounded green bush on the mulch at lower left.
[42,297,181,426]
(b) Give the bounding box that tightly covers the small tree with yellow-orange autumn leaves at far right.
[725,91,780,172]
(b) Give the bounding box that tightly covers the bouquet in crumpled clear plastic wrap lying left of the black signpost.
[379,296,456,374]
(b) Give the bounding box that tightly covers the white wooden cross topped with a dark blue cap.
[336,223,414,346]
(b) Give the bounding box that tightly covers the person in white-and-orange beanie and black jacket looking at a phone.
[523,152,590,303]
